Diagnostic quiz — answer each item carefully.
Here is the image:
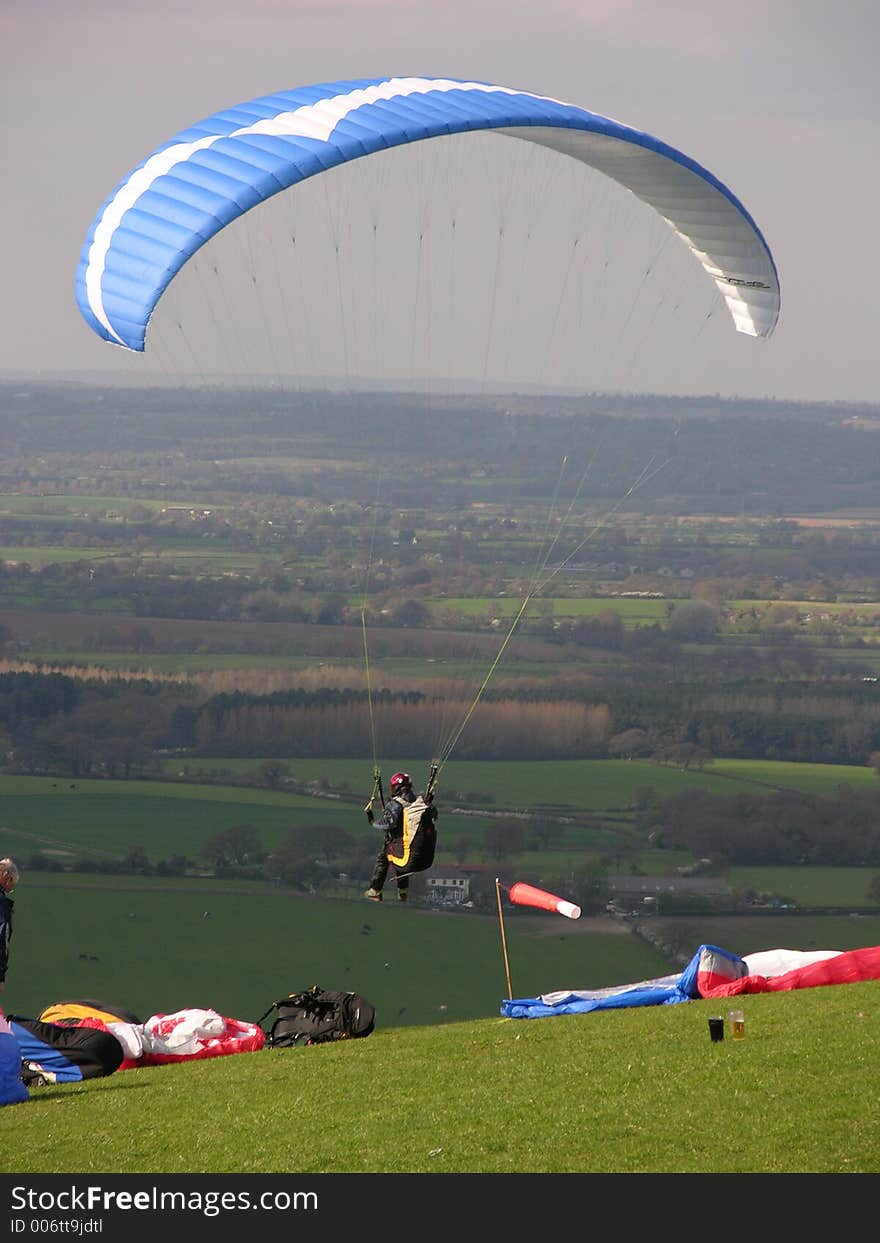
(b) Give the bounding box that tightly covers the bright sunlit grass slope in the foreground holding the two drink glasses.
[0,983,880,1173]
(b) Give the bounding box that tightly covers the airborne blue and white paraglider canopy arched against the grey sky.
[76,77,779,351]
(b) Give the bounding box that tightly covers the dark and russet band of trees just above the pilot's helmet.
[8,671,880,777]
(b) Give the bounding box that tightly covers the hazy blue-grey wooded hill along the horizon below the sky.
[0,380,880,517]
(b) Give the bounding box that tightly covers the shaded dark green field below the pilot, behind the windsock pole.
[4,874,671,1027]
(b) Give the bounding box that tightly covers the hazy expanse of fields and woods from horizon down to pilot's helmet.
[0,383,880,776]
